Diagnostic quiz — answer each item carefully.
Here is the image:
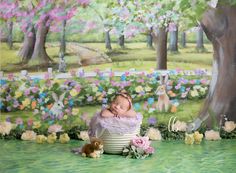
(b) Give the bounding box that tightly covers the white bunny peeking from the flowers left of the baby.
[50,92,65,117]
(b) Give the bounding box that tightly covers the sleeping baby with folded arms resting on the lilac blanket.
[101,92,136,118]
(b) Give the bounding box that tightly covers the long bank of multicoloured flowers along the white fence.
[0,71,209,112]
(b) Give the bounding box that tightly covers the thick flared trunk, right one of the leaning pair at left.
[30,17,52,65]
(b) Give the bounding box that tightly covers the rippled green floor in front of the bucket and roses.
[0,140,236,173]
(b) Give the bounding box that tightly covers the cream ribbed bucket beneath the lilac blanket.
[100,129,140,154]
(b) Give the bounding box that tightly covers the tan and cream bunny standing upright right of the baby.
[155,75,170,112]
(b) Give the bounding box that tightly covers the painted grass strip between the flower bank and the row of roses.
[0,100,203,125]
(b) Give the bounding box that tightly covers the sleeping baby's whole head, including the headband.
[110,92,132,114]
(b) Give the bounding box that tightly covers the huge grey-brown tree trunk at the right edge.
[191,6,236,129]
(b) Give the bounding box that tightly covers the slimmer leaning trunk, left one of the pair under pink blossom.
[18,26,36,63]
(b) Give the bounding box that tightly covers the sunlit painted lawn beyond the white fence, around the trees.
[0,43,212,72]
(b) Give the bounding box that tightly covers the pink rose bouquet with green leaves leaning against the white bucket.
[122,136,154,159]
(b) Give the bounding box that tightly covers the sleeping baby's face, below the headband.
[111,96,130,115]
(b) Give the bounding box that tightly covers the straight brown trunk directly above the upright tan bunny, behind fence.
[156,28,167,70]
